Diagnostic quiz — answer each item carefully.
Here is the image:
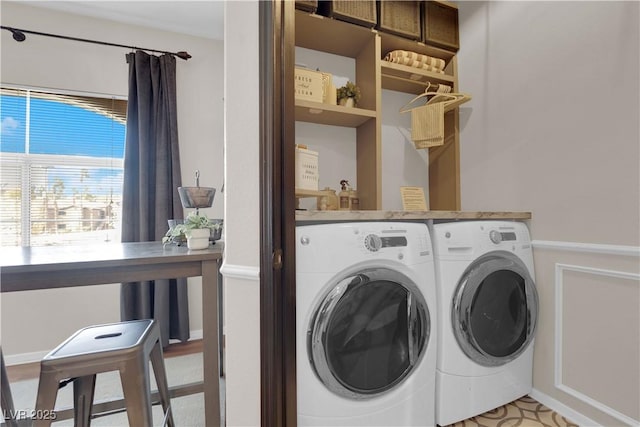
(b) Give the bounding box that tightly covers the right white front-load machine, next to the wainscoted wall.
[431,221,538,426]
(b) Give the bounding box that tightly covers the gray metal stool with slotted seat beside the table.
[33,319,175,427]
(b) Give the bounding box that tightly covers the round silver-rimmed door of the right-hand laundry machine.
[451,251,538,366]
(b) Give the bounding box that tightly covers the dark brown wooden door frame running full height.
[259,0,297,427]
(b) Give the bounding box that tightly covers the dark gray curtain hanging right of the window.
[120,51,189,346]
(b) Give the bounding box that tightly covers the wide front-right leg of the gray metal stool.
[120,357,153,427]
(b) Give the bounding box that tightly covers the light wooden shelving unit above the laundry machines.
[295,6,460,211]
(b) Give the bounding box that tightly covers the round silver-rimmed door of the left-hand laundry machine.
[307,268,430,399]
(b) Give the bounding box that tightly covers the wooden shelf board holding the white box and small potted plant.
[296,99,376,128]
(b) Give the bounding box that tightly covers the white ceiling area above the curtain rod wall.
[22,0,224,40]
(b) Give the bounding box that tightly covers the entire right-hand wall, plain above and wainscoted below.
[458,2,640,426]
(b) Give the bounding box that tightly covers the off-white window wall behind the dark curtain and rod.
[0,1,224,363]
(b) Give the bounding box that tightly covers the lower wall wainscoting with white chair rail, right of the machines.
[532,240,640,426]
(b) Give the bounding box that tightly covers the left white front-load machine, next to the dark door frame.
[296,222,437,426]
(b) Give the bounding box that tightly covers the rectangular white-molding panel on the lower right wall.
[555,264,640,425]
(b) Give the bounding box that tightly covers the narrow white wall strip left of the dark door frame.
[221,1,260,426]
